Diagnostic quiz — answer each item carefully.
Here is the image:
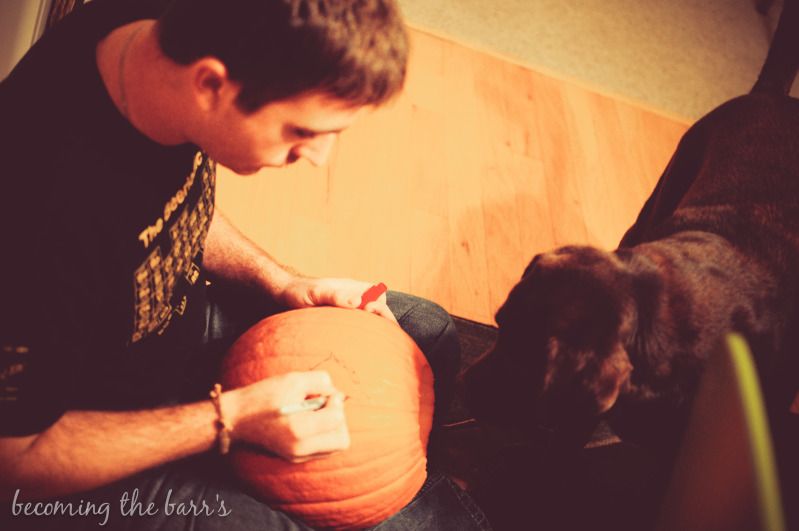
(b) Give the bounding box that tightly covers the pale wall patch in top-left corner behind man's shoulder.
[0,0,50,79]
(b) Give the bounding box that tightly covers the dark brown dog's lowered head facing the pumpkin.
[465,247,635,442]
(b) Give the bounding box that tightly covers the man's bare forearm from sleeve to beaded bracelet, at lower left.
[0,400,219,499]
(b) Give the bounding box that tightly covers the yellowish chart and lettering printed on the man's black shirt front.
[131,153,216,343]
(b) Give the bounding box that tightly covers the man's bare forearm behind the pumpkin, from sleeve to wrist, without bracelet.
[203,209,296,298]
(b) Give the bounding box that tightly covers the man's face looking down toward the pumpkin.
[198,93,364,175]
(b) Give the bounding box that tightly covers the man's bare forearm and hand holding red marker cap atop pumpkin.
[203,209,396,322]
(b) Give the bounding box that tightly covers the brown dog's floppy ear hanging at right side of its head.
[541,337,633,421]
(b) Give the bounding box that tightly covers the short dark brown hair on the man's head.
[158,0,408,112]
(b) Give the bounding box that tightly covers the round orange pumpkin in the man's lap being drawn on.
[221,307,434,529]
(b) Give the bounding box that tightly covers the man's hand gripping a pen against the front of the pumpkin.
[227,371,350,463]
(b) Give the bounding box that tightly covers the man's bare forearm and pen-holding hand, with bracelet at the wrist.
[0,371,349,499]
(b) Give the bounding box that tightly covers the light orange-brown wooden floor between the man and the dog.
[217,31,687,323]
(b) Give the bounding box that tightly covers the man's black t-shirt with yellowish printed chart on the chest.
[0,0,215,435]
